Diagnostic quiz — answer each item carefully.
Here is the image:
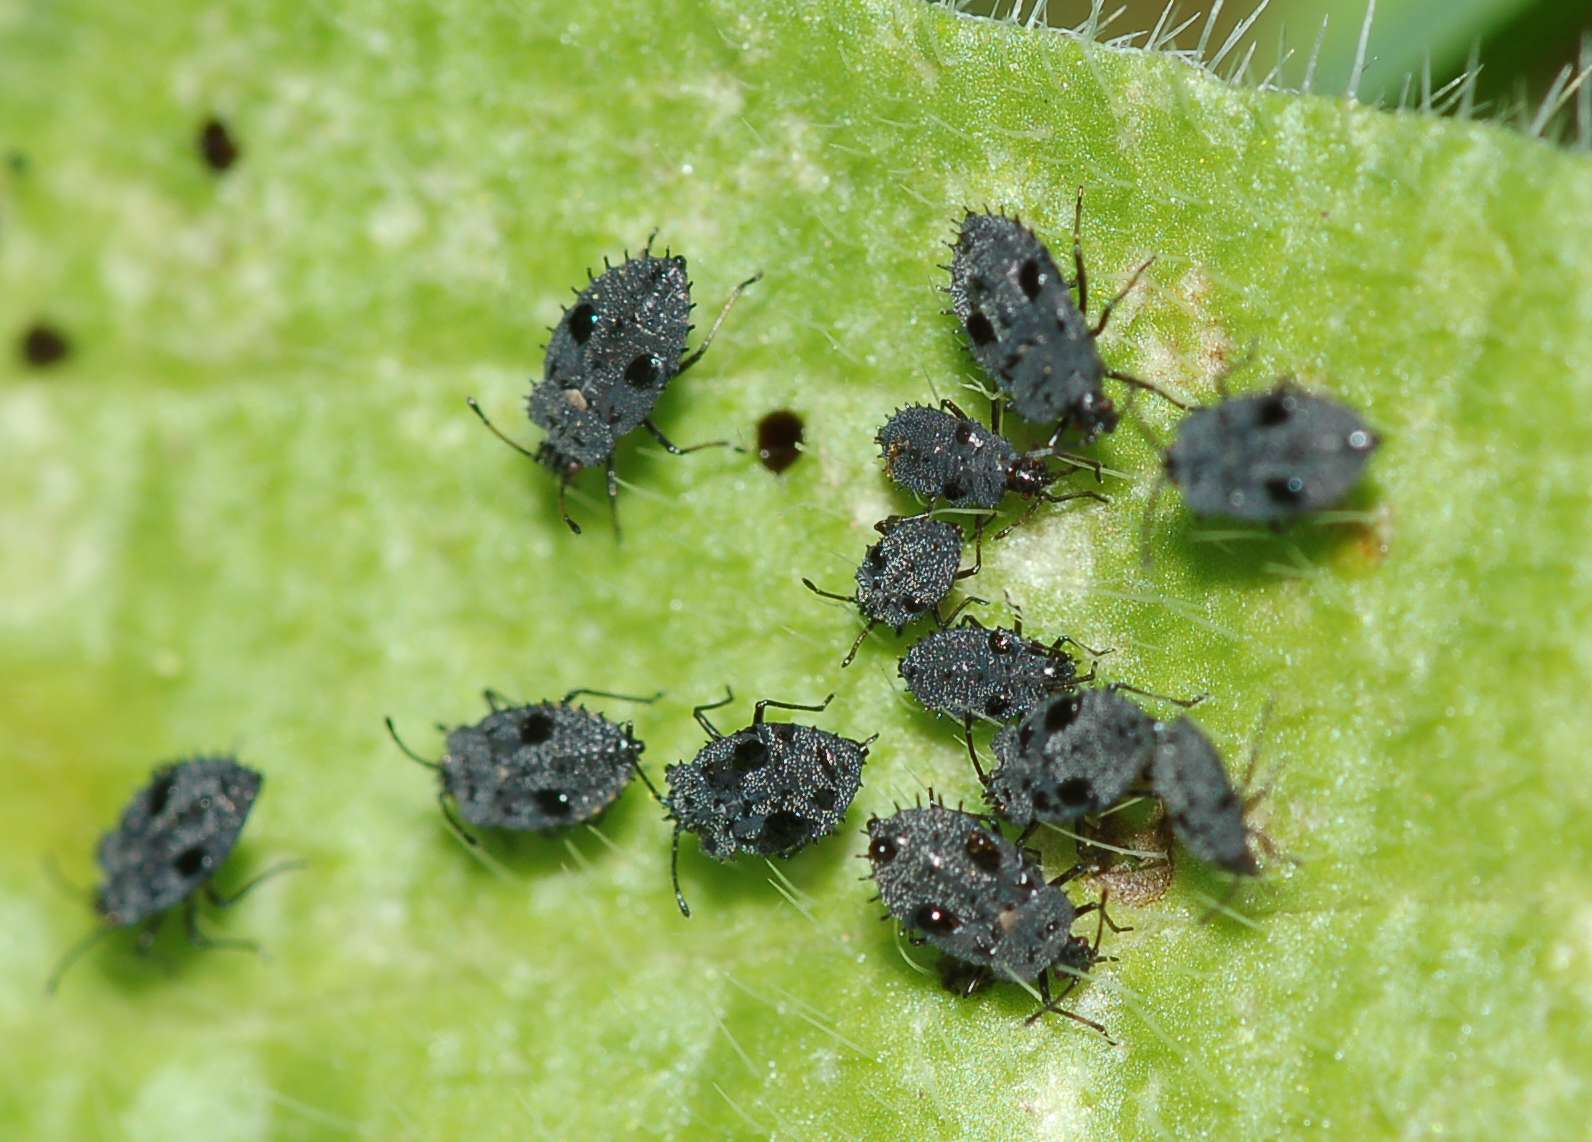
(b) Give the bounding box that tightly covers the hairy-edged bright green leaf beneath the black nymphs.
[0,0,1592,1139]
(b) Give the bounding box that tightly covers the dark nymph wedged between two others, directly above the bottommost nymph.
[979,683,1202,836]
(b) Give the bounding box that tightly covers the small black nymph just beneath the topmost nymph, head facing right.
[876,400,1105,534]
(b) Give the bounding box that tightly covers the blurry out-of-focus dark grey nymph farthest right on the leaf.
[1165,379,1380,522]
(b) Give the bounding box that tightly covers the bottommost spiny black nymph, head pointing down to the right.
[864,800,1126,1034]
